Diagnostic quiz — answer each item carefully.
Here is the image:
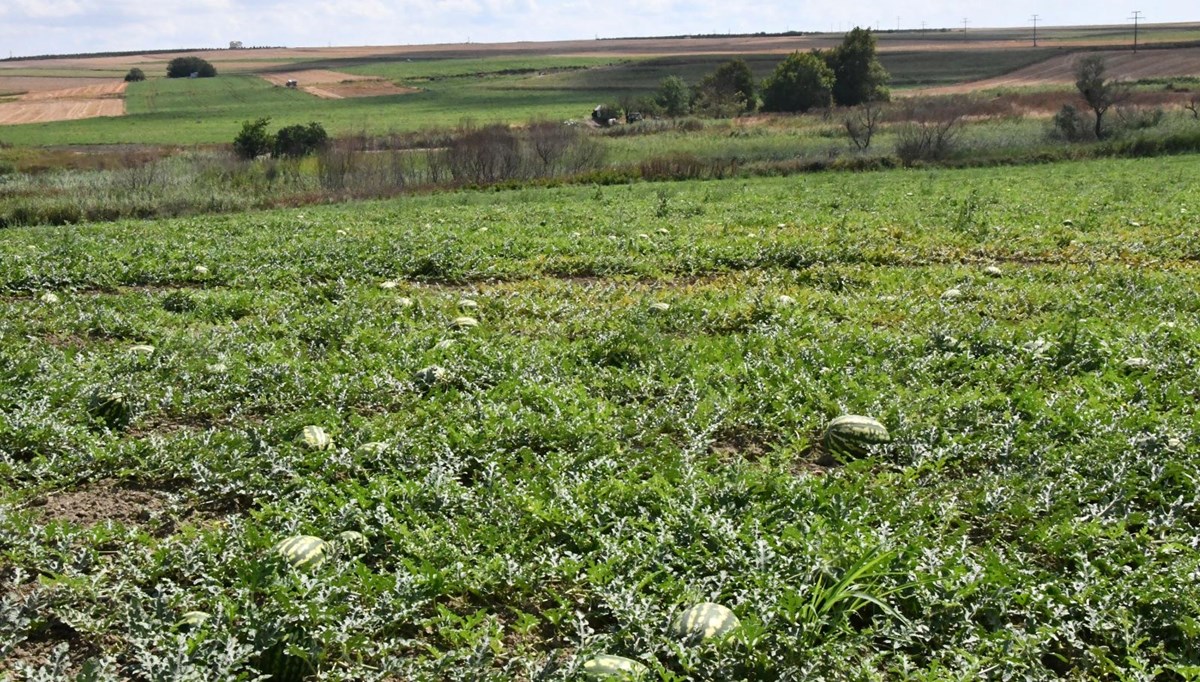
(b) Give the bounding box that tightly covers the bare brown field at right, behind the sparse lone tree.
[904,48,1200,95]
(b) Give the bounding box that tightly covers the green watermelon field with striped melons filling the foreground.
[0,156,1200,681]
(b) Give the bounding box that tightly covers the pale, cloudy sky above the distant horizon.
[0,0,1200,59]
